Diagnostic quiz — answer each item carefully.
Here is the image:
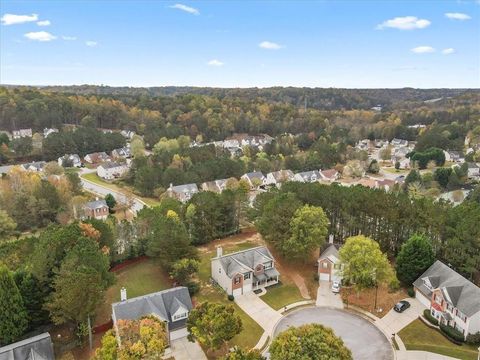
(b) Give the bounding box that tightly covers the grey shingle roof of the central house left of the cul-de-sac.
[212,246,274,278]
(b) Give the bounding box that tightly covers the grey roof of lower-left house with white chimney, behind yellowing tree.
[112,286,193,330]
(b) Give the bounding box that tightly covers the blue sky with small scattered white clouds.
[0,0,480,88]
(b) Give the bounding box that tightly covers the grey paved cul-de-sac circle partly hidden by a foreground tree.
[274,307,394,360]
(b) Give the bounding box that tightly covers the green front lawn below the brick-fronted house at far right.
[398,320,478,360]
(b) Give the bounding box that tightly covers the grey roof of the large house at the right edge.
[413,260,480,316]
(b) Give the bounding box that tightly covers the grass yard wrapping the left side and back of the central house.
[195,241,263,348]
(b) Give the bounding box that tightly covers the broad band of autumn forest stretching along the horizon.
[0,86,480,147]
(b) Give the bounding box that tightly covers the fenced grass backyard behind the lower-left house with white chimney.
[95,259,171,325]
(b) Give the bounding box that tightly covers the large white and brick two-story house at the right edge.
[413,260,480,337]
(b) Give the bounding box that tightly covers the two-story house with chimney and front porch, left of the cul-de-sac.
[211,246,280,296]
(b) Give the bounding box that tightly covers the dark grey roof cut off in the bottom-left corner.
[0,332,55,360]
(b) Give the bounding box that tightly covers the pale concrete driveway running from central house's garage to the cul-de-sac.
[235,292,282,333]
